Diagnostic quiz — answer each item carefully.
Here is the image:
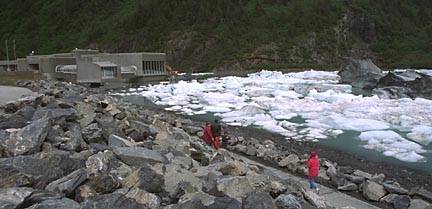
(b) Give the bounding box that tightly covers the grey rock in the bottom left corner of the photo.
[0,187,33,209]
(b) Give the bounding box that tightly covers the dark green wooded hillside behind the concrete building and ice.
[0,0,432,71]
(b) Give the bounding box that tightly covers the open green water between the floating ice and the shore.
[122,95,432,172]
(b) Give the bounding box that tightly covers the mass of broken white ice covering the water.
[116,70,432,162]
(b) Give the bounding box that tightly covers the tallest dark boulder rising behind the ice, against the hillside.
[338,58,384,89]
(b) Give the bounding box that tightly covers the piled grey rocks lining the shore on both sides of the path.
[0,81,432,209]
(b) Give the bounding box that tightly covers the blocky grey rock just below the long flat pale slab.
[123,165,165,193]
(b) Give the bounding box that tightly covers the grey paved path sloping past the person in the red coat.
[232,153,379,209]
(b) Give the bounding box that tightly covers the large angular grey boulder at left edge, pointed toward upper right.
[0,119,50,156]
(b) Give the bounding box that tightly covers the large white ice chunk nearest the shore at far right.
[359,131,425,162]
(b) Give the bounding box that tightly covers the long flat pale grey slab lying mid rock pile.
[113,147,167,166]
